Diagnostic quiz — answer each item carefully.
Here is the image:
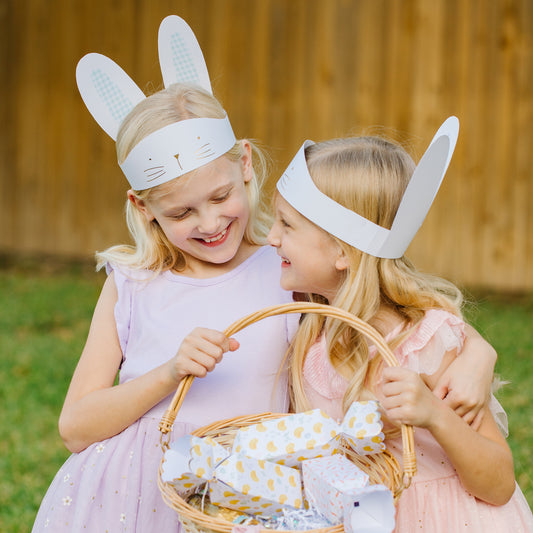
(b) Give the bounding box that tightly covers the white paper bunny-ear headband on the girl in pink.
[277,117,459,259]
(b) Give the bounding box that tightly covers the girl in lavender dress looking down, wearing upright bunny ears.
[33,17,295,533]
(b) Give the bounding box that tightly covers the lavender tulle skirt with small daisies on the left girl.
[32,417,196,533]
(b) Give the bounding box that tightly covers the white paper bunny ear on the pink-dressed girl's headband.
[380,116,459,258]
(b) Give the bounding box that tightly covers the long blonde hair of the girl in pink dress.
[289,137,462,411]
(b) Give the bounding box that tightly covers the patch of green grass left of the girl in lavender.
[0,264,101,532]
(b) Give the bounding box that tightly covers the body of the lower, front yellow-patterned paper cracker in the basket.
[209,455,302,515]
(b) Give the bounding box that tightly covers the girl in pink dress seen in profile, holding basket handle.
[268,117,533,533]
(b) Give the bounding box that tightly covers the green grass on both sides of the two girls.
[0,261,533,532]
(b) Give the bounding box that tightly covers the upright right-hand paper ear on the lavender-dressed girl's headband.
[158,15,213,93]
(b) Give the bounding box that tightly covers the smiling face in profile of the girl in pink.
[268,194,346,302]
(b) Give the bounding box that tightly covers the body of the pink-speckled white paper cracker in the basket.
[302,454,369,524]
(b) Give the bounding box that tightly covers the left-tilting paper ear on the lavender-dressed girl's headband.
[76,53,146,140]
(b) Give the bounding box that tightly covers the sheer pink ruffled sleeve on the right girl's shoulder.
[395,309,465,375]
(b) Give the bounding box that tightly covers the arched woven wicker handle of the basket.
[159,302,416,488]
